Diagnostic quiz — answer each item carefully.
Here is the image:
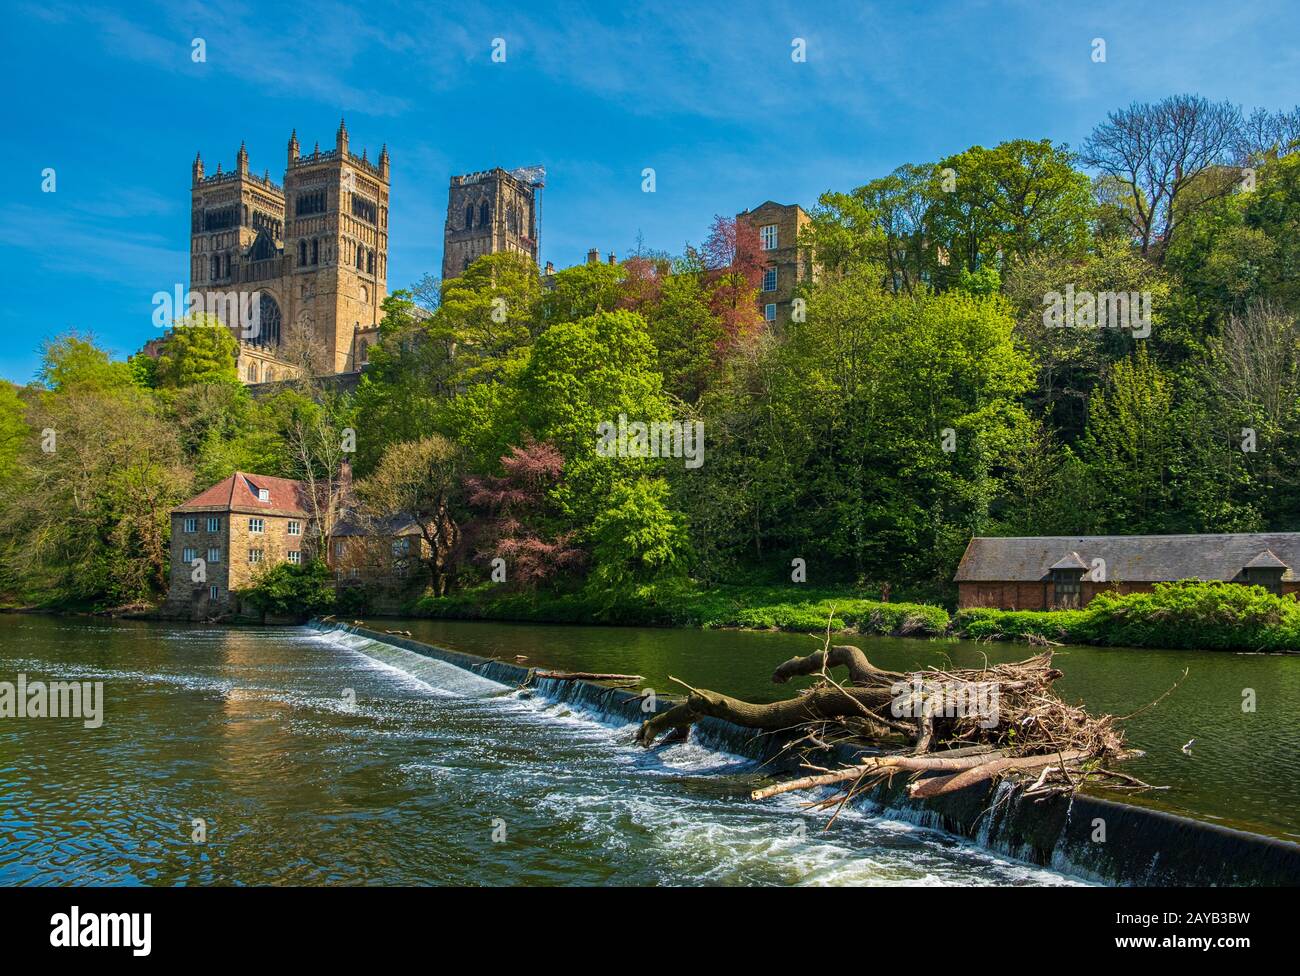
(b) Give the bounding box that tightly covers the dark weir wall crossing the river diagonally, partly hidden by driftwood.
[308,620,1300,886]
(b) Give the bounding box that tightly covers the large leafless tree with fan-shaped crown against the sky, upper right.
[1082,95,1243,264]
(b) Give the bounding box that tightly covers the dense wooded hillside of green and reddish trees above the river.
[0,96,1300,649]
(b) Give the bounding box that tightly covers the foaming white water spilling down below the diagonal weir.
[317,632,1084,886]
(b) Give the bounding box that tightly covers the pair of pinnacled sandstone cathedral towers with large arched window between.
[190,122,389,383]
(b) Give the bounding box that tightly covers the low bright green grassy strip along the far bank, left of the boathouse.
[412,584,950,637]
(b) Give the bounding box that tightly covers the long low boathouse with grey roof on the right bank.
[954,532,1300,610]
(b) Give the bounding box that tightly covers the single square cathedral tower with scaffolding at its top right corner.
[442,166,546,281]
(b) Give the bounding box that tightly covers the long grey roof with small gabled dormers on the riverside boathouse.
[954,532,1300,582]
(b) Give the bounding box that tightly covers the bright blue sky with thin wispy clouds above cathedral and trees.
[0,0,1300,382]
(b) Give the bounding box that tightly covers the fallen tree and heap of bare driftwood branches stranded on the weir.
[637,634,1152,807]
